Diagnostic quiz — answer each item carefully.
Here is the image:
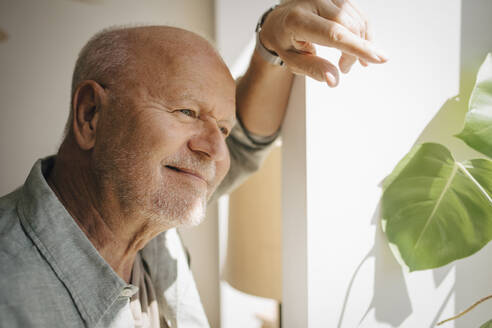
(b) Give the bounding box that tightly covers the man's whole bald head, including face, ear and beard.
[54,26,236,228]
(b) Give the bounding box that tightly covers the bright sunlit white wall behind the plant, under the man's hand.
[283,0,492,328]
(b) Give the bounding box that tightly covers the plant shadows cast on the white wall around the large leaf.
[337,89,492,328]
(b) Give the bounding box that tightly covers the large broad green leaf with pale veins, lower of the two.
[382,143,492,271]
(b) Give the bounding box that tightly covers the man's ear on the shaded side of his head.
[72,80,107,150]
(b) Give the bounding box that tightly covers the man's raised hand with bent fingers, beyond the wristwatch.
[260,0,388,87]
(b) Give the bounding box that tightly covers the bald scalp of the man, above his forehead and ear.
[65,26,233,134]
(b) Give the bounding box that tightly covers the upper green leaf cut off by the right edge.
[456,53,492,157]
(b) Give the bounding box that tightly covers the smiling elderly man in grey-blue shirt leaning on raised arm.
[0,0,386,327]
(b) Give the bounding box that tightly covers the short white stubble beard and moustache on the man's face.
[96,142,215,229]
